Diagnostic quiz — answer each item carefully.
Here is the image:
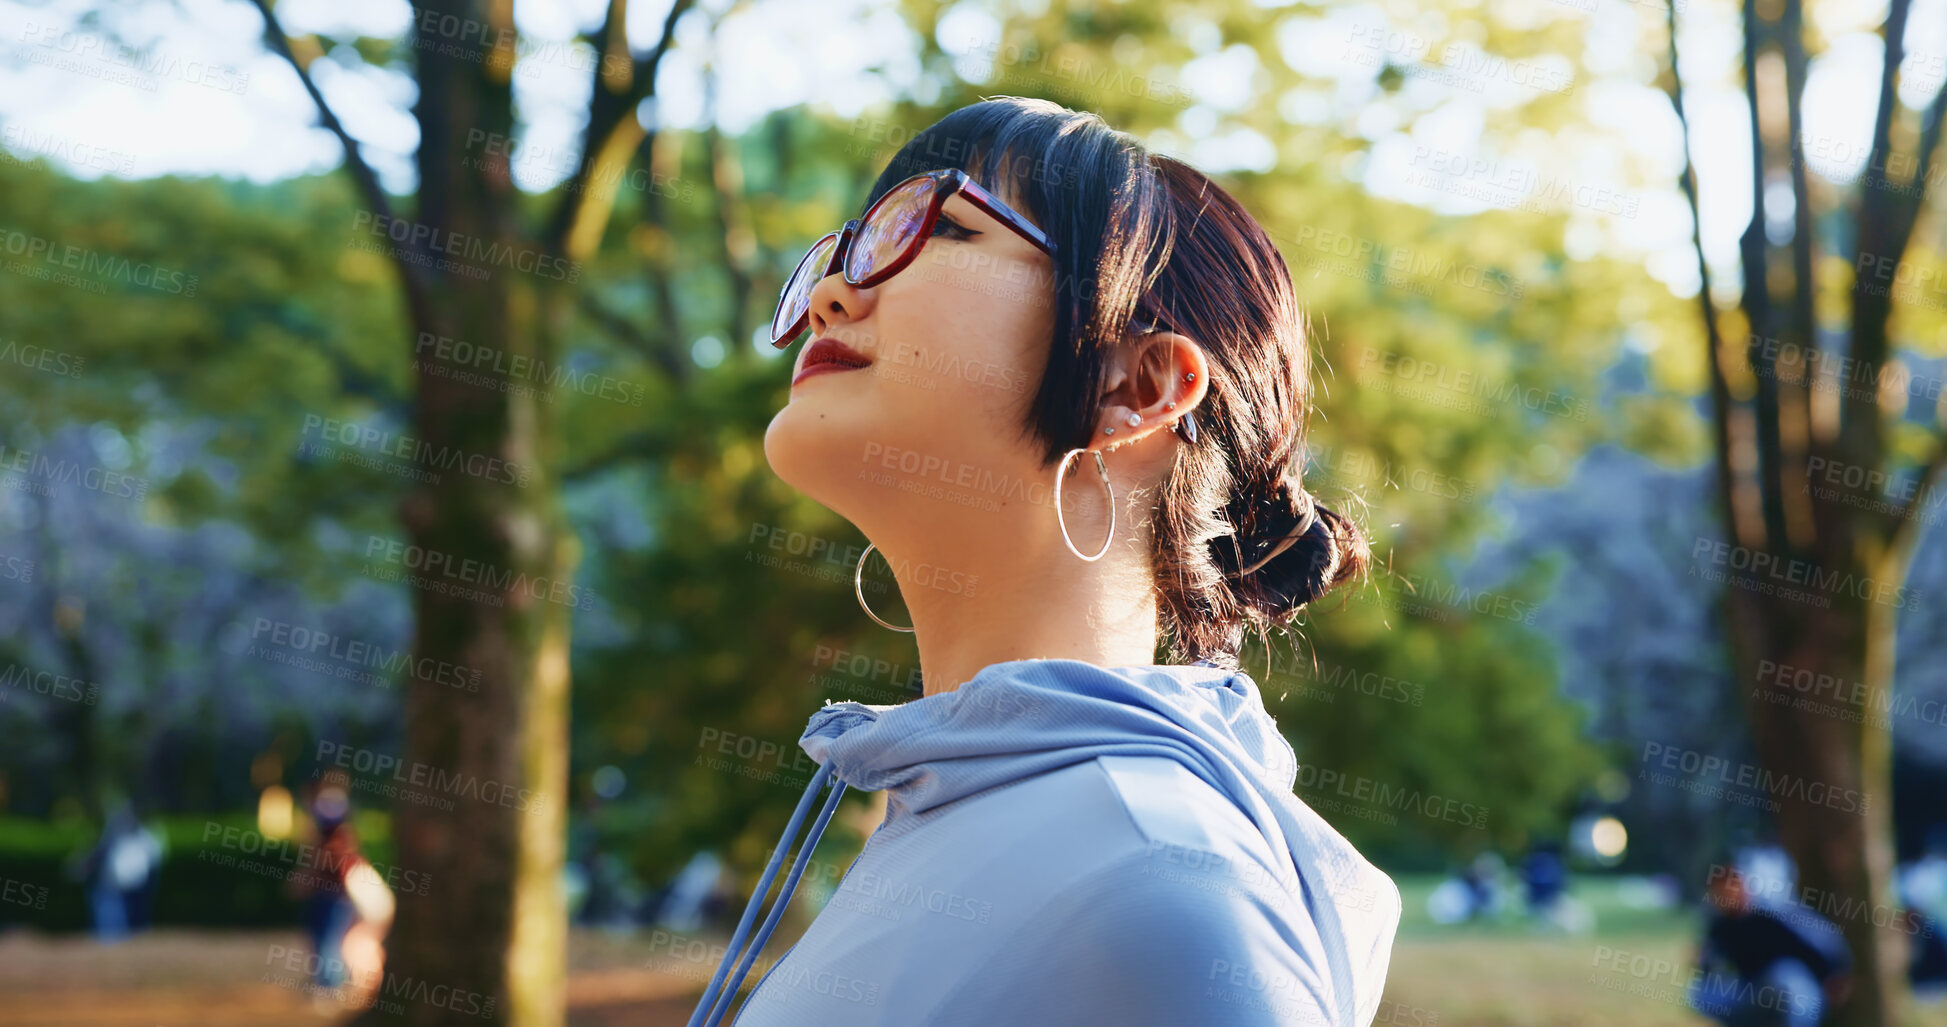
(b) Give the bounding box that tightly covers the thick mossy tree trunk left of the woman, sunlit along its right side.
[366,0,572,1027]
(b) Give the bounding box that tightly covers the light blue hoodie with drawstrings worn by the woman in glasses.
[693,659,1400,1027]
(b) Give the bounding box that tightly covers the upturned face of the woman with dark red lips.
[763,179,1055,561]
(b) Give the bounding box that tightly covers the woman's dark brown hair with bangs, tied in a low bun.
[866,97,1371,666]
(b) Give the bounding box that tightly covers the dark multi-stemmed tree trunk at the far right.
[1665,0,1947,1027]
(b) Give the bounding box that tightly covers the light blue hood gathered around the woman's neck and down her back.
[798,659,1400,1023]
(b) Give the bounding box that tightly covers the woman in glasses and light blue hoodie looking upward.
[691,97,1400,1027]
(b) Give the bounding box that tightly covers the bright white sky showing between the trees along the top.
[0,0,1947,302]
